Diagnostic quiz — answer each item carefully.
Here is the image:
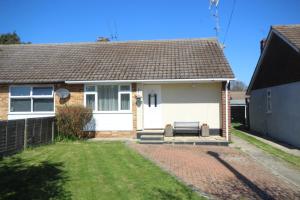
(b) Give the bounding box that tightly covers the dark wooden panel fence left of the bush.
[0,117,56,157]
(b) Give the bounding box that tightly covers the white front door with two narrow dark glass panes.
[143,85,163,129]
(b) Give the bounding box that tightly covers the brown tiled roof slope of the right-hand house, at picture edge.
[272,24,300,50]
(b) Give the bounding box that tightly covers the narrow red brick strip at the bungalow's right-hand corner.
[221,82,231,140]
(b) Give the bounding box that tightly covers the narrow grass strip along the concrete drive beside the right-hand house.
[231,125,300,169]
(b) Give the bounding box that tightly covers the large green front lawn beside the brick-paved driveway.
[0,142,202,199]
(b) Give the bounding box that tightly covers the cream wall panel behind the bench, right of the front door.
[161,83,221,129]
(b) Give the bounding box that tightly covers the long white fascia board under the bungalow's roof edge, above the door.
[65,78,236,84]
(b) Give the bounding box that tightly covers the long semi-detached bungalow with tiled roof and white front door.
[0,39,234,139]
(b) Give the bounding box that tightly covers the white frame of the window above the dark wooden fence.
[8,85,55,114]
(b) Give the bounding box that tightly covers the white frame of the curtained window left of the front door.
[84,83,132,113]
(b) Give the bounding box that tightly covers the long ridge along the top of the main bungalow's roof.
[0,37,219,47]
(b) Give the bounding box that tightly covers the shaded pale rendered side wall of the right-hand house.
[249,82,300,147]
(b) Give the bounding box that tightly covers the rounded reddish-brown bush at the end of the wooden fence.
[56,105,93,138]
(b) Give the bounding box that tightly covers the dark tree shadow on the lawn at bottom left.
[0,158,71,200]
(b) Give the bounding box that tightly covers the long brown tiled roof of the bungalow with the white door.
[0,39,234,83]
